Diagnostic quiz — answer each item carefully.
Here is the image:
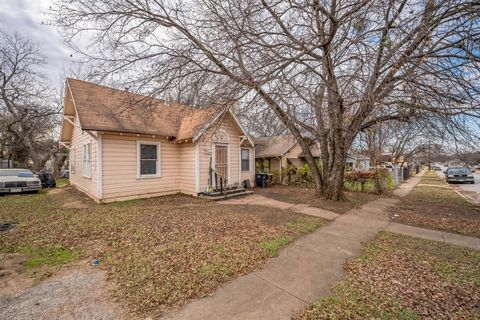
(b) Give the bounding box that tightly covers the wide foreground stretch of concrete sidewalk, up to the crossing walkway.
[162,202,389,320]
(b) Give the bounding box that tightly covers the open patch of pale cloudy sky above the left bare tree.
[0,0,73,88]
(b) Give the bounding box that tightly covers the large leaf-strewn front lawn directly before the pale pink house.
[0,186,326,317]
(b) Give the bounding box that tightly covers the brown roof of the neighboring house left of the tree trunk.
[253,134,297,158]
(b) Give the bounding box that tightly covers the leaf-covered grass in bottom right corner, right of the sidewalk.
[299,232,480,320]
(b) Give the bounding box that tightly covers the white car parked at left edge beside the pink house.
[0,169,42,193]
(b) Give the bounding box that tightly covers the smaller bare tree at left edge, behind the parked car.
[0,32,61,167]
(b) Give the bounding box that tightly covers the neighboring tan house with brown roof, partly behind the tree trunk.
[253,135,303,173]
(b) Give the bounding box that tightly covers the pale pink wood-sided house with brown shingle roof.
[60,78,255,202]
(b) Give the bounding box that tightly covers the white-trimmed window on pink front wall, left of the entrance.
[137,141,160,178]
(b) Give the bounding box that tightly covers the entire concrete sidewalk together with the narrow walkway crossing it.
[162,174,480,320]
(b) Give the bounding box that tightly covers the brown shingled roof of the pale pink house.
[60,78,225,140]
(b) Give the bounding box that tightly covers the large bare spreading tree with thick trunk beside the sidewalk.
[52,0,480,200]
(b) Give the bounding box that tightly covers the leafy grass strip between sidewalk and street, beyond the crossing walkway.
[391,171,480,237]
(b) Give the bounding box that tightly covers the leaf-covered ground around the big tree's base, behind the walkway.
[255,185,378,214]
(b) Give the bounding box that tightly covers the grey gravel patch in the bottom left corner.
[0,266,125,320]
